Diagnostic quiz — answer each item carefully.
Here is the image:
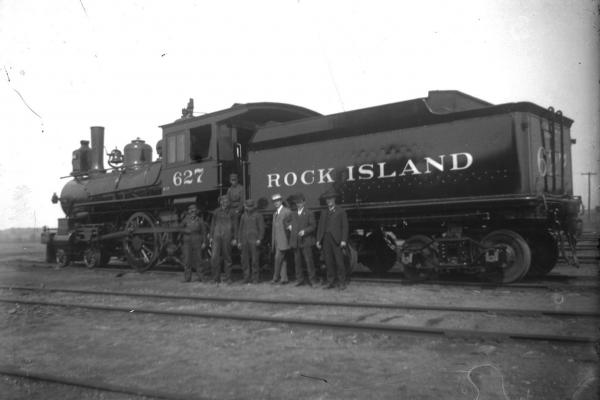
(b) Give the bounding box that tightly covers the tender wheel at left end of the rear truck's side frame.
[401,235,439,281]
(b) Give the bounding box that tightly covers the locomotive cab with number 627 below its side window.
[161,103,319,208]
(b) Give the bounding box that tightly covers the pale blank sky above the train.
[0,0,600,229]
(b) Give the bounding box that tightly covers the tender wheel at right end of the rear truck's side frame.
[481,229,531,283]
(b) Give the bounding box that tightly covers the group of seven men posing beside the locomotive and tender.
[181,174,348,290]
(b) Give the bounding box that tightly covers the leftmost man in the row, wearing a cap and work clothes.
[180,204,206,282]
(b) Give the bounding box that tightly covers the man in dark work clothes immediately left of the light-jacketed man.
[237,199,265,283]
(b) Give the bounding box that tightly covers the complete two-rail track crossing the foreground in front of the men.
[0,286,600,344]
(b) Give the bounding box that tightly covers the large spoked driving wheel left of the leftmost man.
[123,212,160,272]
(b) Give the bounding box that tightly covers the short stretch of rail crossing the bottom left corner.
[0,365,208,400]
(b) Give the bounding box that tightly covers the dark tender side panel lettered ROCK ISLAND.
[249,114,523,207]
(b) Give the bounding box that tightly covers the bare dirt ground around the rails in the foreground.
[0,244,598,400]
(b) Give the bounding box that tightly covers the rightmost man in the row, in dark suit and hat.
[317,190,348,290]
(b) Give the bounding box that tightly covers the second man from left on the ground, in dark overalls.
[210,196,237,284]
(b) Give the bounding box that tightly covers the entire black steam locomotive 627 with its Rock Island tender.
[43,91,579,283]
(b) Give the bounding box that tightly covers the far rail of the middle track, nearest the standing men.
[0,286,600,318]
